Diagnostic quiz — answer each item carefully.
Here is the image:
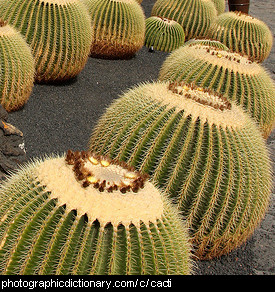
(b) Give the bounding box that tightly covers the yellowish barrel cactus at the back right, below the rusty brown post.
[208,11,273,62]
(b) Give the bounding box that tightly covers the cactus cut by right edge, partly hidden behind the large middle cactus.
[159,43,275,138]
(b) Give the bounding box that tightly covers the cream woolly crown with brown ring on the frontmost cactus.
[35,151,163,227]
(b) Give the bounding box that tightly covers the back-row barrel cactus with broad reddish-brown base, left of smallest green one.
[82,0,145,59]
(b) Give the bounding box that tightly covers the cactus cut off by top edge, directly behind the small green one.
[151,0,217,40]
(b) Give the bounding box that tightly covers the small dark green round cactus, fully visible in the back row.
[145,16,185,52]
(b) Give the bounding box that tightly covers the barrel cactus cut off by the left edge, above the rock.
[0,20,35,111]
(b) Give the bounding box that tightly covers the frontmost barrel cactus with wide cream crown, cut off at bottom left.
[0,150,192,275]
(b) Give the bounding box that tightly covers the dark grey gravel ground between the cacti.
[5,0,275,275]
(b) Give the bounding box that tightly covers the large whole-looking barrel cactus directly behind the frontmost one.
[89,82,271,259]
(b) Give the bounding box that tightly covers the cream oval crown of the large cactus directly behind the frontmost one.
[148,81,246,128]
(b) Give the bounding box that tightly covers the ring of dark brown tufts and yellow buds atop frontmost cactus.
[65,150,148,194]
